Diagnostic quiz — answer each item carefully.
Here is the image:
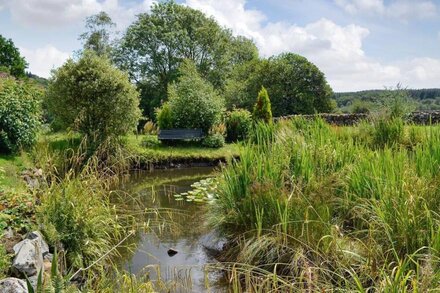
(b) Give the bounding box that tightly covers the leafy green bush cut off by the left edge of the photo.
[0,78,42,153]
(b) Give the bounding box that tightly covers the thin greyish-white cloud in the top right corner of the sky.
[334,0,437,21]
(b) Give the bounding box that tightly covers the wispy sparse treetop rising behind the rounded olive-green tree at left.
[79,11,115,56]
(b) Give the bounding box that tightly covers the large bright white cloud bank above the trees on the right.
[186,0,440,91]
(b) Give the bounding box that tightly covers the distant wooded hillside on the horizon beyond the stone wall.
[333,88,440,113]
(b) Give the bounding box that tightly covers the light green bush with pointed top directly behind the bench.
[168,60,223,133]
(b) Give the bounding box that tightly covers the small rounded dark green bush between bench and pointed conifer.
[226,109,252,142]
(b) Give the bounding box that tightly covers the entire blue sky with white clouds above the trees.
[0,0,440,92]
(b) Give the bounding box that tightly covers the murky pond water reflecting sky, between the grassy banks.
[114,167,227,292]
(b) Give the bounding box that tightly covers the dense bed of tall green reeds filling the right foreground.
[212,118,440,292]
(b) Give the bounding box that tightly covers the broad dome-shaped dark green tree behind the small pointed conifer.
[225,53,332,116]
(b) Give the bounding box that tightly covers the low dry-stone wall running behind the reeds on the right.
[275,111,440,126]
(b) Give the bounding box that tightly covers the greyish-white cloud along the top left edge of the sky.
[0,0,154,27]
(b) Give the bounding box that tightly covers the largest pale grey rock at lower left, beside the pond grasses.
[12,231,49,277]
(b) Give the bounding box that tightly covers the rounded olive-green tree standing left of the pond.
[47,51,140,140]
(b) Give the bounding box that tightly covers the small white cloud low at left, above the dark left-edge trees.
[19,45,69,78]
